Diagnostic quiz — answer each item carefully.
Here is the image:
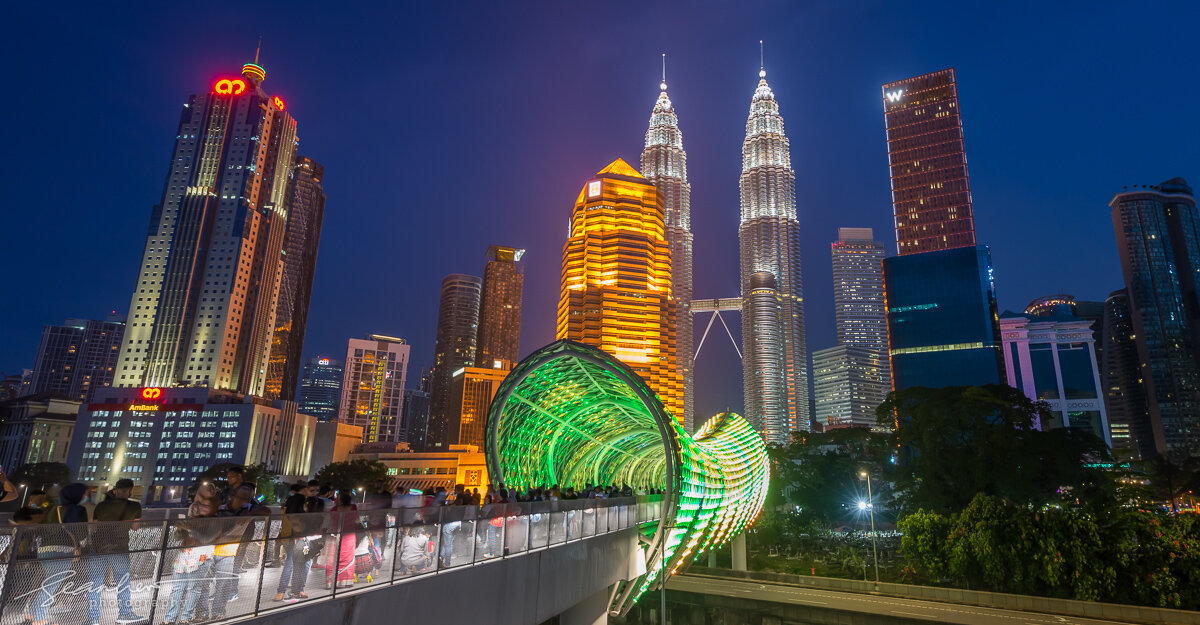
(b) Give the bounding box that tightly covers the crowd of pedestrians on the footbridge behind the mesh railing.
[0,467,653,625]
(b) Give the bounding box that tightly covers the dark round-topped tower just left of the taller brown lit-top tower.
[426,274,484,449]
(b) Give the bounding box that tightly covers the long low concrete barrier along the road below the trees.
[684,566,1200,625]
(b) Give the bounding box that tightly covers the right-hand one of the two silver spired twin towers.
[738,60,811,443]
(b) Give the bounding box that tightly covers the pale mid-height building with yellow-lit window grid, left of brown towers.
[337,335,412,443]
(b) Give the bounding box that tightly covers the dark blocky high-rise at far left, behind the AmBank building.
[25,314,125,402]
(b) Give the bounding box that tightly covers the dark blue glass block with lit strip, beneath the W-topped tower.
[883,246,1006,391]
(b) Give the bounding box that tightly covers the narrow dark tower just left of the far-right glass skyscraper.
[1100,289,1156,461]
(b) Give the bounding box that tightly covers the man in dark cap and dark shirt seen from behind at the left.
[88,477,145,624]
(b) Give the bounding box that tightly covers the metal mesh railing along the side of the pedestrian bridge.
[0,497,661,625]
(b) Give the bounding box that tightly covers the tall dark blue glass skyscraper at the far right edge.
[1109,178,1200,459]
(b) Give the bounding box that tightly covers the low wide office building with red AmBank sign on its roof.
[67,387,317,503]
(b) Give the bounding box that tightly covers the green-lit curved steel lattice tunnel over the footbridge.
[486,341,768,614]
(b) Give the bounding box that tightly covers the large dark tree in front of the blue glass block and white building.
[876,385,1115,513]
